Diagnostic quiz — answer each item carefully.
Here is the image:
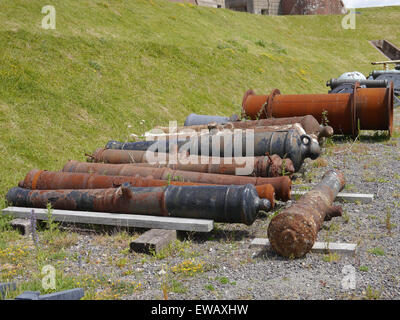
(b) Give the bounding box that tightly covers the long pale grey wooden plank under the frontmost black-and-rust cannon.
[2,207,214,232]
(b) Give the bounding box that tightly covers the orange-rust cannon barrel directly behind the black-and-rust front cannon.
[18,169,275,207]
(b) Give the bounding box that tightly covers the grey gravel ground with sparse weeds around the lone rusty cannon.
[57,110,400,300]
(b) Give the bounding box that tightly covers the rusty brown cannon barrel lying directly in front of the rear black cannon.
[88,148,294,177]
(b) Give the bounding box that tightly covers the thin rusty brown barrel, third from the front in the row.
[62,161,292,201]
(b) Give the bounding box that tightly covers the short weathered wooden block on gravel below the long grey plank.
[129,229,176,253]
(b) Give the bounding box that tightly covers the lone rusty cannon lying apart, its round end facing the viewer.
[268,170,345,258]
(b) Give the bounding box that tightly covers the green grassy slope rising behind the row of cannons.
[0,0,400,201]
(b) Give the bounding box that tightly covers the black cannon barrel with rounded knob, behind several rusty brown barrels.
[106,128,321,172]
